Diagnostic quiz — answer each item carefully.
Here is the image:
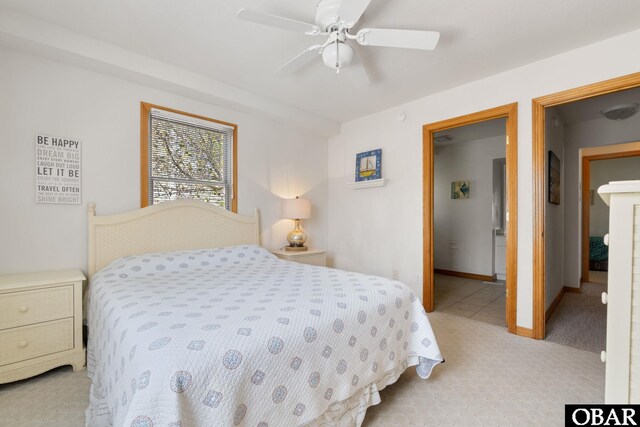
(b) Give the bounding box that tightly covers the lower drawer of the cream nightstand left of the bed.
[0,317,73,366]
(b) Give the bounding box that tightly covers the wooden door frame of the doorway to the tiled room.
[422,103,516,335]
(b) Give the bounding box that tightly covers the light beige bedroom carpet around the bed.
[0,313,604,427]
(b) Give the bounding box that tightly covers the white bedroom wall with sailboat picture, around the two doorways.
[329,31,640,328]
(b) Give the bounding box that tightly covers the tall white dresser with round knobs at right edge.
[598,181,640,404]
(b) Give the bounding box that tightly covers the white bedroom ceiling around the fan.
[0,0,640,122]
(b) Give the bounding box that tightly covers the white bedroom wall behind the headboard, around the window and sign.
[0,47,327,273]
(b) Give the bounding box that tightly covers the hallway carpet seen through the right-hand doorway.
[545,283,607,354]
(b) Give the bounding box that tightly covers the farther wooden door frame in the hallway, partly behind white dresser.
[580,142,640,284]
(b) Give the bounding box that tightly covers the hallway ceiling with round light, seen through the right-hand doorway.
[550,88,640,124]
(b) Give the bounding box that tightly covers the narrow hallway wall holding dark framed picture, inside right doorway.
[544,110,566,310]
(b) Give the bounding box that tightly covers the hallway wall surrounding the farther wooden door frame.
[564,114,640,287]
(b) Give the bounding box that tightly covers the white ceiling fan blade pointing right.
[357,28,440,50]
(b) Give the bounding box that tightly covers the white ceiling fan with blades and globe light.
[236,0,440,82]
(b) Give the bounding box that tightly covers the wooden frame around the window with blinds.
[140,102,238,213]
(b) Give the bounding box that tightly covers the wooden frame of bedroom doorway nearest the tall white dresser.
[531,73,640,339]
